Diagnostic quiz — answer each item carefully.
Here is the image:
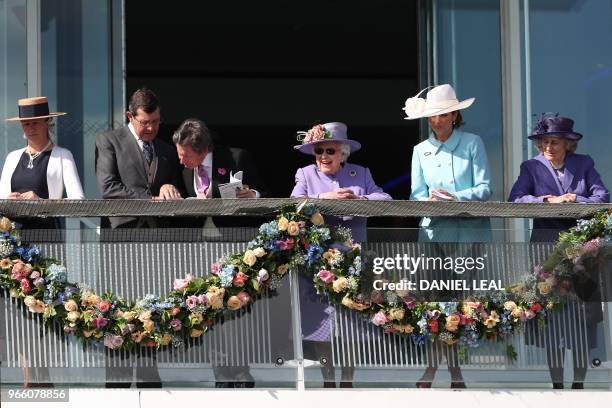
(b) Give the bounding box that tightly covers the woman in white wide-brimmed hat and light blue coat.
[404,84,491,388]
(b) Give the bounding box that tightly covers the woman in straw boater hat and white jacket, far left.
[0,96,84,226]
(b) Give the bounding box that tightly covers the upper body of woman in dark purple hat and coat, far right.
[508,113,610,242]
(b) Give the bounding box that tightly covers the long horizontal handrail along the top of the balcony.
[0,198,612,218]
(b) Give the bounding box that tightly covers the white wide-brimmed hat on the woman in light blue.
[402,84,476,120]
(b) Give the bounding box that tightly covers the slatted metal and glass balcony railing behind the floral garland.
[0,199,612,388]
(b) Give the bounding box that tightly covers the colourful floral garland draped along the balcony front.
[0,206,612,358]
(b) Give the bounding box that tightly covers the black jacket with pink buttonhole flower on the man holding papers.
[179,146,266,227]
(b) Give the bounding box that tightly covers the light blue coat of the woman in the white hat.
[410,130,491,242]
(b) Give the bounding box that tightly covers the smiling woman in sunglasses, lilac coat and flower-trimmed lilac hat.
[291,122,391,388]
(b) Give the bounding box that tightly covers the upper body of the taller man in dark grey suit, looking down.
[96,88,181,228]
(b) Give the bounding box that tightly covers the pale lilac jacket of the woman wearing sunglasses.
[291,163,391,242]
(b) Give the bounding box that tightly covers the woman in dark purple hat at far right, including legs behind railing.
[509,113,610,389]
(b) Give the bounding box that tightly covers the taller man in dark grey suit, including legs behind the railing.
[95,88,181,388]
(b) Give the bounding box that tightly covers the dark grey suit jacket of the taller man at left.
[95,126,180,228]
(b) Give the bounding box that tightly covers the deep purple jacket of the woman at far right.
[508,153,610,241]
